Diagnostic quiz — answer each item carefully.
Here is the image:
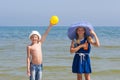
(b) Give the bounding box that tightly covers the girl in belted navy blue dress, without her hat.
[70,26,100,80]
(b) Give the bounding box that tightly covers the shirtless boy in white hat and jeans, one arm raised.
[27,24,53,80]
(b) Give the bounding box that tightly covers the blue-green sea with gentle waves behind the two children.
[0,26,120,80]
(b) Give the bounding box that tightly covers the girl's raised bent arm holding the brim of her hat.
[88,30,100,47]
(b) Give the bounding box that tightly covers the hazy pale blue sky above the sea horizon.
[0,0,120,26]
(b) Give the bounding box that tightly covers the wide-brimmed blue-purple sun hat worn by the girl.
[67,21,94,40]
